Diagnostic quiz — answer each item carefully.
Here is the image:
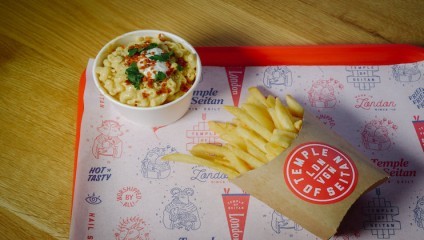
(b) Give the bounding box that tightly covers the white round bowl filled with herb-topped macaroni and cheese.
[92,30,202,127]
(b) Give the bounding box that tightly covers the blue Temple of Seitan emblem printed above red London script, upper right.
[346,66,381,90]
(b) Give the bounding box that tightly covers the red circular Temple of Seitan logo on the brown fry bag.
[283,142,358,204]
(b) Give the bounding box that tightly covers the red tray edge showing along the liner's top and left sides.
[71,44,424,211]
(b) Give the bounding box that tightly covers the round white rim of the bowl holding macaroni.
[91,29,202,111]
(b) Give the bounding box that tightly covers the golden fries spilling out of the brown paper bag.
[162,87,304,179]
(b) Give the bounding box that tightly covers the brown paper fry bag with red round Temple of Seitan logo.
[231,112,388,239]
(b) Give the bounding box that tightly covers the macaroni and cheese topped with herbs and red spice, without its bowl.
[95,34,197,107]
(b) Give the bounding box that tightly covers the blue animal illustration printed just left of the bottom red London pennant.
[163,187,200,231]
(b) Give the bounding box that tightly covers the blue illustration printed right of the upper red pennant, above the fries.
[263,66,293,88]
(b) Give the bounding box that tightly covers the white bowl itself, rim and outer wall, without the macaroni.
[92,30,202,127]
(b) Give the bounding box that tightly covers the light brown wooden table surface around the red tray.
[0,0,424,239]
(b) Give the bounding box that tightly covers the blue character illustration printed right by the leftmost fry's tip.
[141,145,176,179]
